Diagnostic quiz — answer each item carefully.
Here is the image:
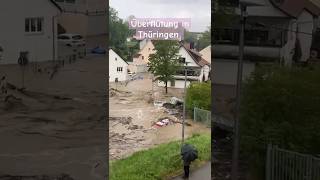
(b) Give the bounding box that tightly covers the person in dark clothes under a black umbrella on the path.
[181,144,198,179]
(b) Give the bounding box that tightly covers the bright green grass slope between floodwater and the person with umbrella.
[109,134,211,180]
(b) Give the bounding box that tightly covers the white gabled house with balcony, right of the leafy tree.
[158,45,211,88]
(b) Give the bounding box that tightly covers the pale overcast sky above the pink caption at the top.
[109,0,211,32]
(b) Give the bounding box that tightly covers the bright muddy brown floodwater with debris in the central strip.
[109,74,210,160]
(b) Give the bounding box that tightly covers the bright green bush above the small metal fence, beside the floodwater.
[186,82,211,112]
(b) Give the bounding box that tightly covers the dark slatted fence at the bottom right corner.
[266,145,320,180]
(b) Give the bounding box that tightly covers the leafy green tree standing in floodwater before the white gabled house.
[148,40,181,94]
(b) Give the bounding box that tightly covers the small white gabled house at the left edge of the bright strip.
[109,49,128,82]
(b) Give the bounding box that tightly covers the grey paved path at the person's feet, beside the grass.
[173,162,211,180]
